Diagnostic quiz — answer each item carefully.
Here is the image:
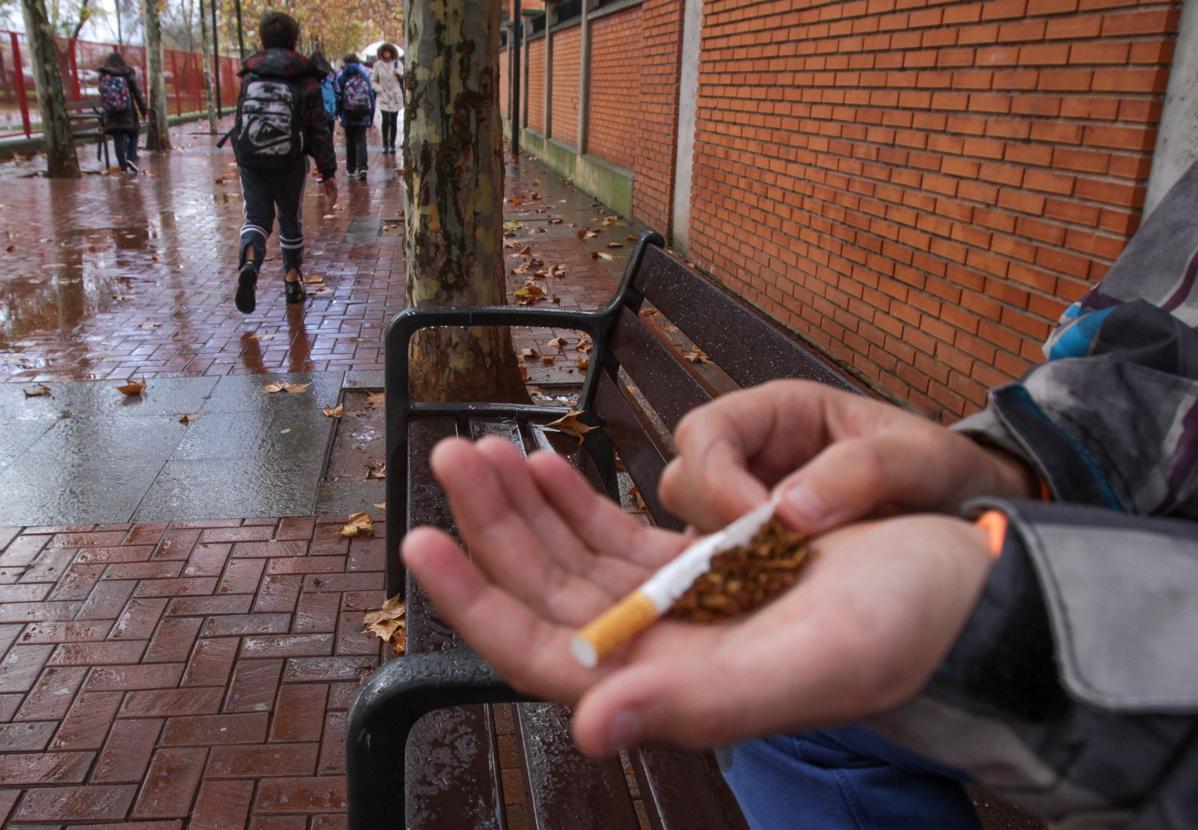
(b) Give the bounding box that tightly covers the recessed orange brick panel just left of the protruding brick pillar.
[587,6,642,170]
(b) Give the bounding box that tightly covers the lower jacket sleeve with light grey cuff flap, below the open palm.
[869,502,1198,830]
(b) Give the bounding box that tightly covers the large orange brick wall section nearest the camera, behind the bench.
[685,0,1178,417]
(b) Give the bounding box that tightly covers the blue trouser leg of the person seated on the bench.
[716,726,981,830]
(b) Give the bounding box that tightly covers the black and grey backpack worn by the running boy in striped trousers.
[232,74,303,170]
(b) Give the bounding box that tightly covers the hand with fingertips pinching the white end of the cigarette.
[660,381,1036,533]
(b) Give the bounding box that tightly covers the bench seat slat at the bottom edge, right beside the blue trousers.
[633,744,749,830]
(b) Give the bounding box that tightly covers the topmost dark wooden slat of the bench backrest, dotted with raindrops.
[634,248,860,392]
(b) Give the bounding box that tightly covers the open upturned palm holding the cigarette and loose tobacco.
[403,440,991,756]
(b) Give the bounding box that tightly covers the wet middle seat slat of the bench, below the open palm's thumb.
[516,703,640,830]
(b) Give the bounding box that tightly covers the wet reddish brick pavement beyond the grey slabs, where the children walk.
[0,117,628,382]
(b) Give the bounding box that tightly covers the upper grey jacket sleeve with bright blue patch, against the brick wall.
[954,164,1198,517]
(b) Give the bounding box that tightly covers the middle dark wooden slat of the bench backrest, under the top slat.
[611,308,712,430]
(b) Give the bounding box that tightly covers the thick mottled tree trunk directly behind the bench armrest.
[404,0,528,401]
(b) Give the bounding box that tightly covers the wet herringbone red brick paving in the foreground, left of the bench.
[0,519,385,830]
